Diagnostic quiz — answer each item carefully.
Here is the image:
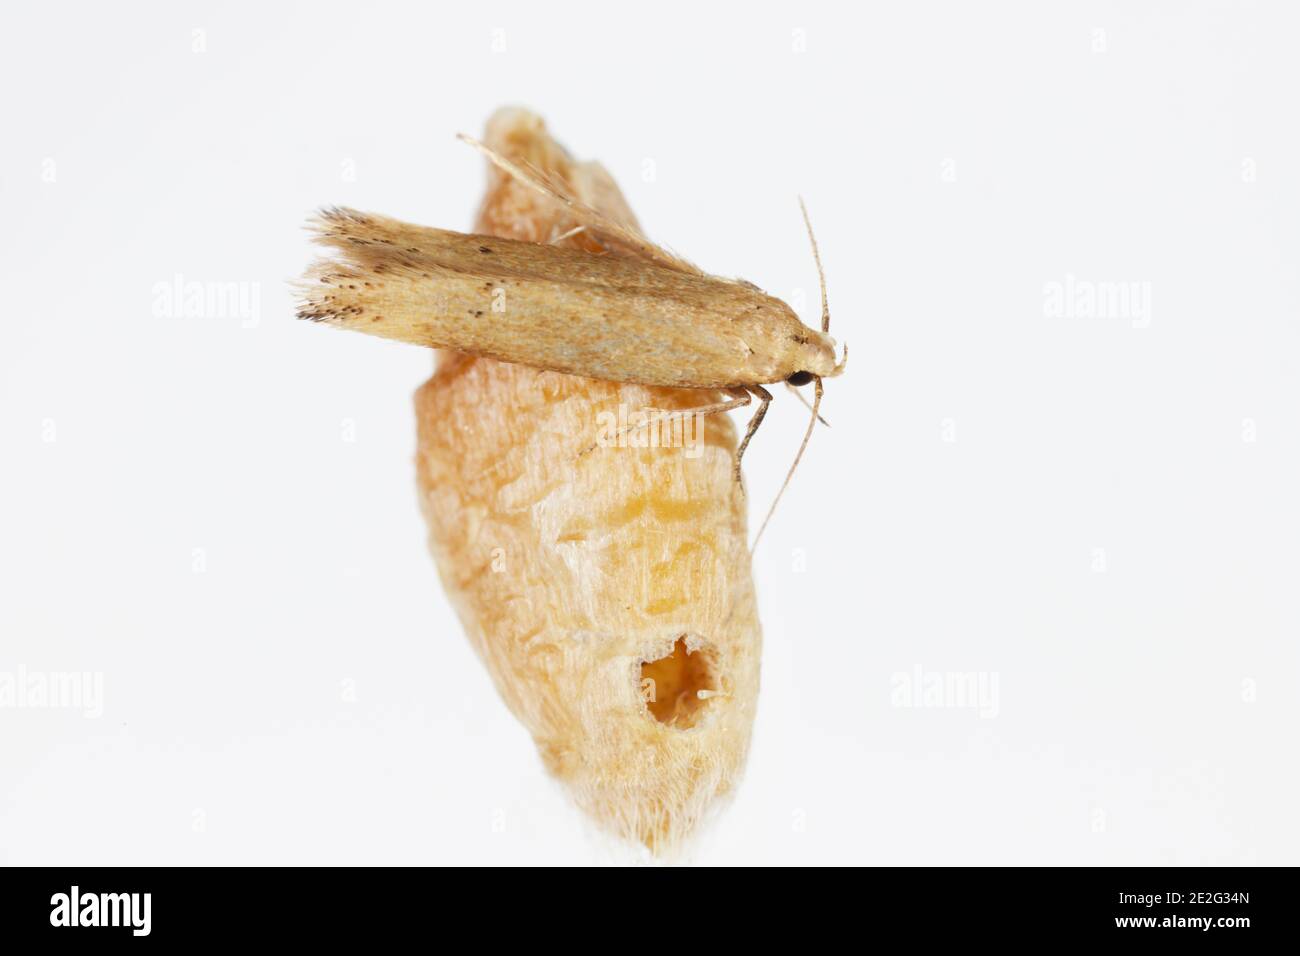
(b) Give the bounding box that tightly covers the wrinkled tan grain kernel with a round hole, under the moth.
[300,108,833,853]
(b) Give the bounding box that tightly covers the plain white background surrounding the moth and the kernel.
[0,3,1300,864]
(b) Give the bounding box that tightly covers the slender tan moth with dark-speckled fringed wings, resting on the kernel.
[298,134,848,544]
